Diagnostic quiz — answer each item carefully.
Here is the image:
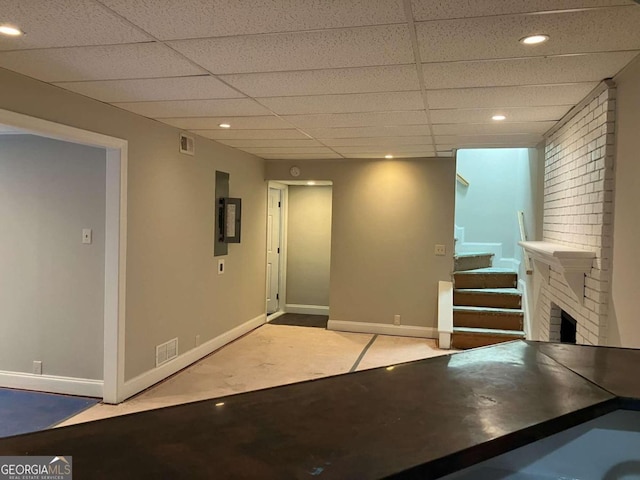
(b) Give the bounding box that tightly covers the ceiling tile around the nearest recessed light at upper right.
[416,6,640,63]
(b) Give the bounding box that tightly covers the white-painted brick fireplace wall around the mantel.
[535,82,616,345]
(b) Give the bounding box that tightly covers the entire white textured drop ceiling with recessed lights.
[0,0,640,159]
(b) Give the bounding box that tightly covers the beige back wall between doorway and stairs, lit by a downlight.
[267,158,456,327]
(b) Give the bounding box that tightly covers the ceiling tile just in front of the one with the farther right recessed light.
[427,82,598,109]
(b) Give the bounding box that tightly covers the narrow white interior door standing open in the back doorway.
[267,188,282,314]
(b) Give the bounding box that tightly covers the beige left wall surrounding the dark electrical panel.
[0,69,267,379]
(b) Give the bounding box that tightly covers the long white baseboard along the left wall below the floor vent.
[119,313,266,402]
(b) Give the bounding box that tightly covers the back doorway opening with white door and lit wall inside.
[266,180,333,328]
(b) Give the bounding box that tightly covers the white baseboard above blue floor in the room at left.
[0,371,103,398]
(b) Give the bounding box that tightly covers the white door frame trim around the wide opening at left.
[0,109,128,403]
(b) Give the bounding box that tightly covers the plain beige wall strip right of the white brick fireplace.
[607,55,640,348]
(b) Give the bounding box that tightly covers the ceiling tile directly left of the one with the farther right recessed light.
[282,110,427,128]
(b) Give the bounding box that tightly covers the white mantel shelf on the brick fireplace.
[518,242,596,303]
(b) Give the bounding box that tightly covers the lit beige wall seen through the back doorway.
[287,185,331,306]
